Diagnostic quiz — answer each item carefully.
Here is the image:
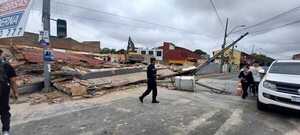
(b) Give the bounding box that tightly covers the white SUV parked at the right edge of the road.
[257,60,300,110]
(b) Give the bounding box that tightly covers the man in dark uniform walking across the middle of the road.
[139,58,159,104]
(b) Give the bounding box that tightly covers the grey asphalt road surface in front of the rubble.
[12,86,300,135]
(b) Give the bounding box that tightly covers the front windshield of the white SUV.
[269,62,300,75]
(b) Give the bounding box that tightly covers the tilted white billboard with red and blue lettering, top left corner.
[0,0,33,38]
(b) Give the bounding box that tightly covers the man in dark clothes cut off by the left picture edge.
[0,49,18,135]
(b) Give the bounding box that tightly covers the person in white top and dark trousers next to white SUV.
[250,62,264,96]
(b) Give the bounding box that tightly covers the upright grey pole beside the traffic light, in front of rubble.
[42,0,51,92]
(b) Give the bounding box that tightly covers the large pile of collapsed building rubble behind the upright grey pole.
[1,46,179,104]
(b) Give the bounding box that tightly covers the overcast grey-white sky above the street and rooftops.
[21,0,300,59]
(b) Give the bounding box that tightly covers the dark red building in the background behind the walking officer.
[159,42,203,65]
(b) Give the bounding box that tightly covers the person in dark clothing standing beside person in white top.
[239,65,253,99]
